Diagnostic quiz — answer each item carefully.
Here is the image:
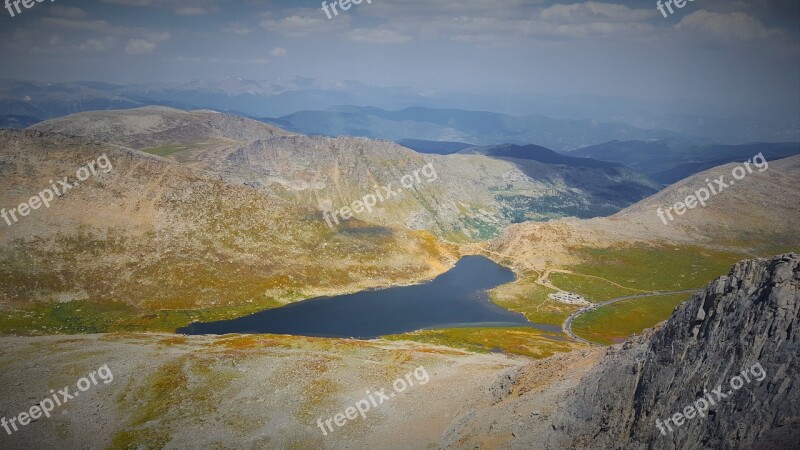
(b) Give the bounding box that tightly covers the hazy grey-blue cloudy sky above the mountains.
[0,0,800,107]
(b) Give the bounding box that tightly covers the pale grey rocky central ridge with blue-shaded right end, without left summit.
[214,136,655,234]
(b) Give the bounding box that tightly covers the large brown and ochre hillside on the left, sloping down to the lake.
[0,130,456,334]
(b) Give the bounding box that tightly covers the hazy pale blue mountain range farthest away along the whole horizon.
[0,77,800,145]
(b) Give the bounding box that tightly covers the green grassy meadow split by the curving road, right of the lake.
[466,245,764,348]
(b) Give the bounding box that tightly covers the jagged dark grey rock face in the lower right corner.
[547,254,800,449]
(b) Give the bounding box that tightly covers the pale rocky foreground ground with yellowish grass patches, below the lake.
[0,334,527,449]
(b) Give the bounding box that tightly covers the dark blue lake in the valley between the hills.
[178,256,561,339]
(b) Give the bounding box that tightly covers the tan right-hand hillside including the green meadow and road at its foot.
[450,156,800,343]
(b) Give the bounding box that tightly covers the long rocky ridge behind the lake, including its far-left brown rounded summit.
[25,107,655,242]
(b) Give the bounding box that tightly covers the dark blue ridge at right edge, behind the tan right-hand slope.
[569,140,800,184]
